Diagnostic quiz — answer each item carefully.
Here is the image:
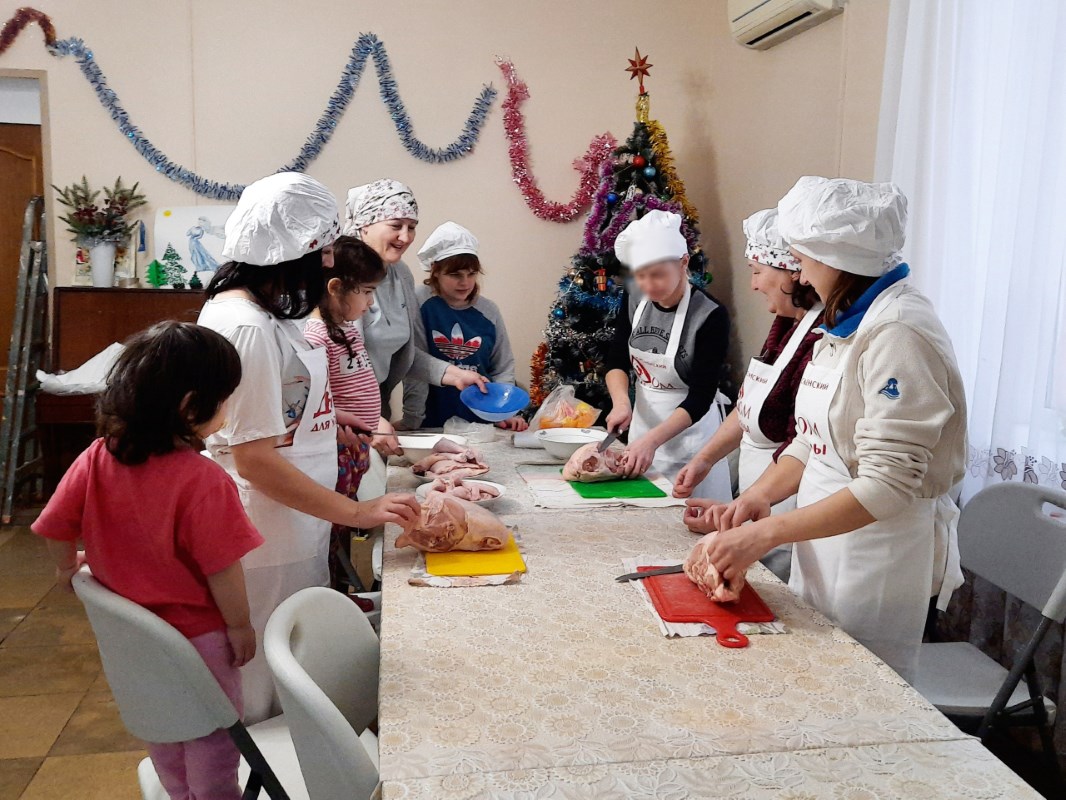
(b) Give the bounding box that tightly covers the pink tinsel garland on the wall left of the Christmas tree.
[496,57,618,222]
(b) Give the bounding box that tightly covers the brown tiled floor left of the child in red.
[0,528,145,800]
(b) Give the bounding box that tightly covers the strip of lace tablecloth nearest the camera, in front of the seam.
[383,740,1039,800]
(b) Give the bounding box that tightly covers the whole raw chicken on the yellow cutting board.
[397,492,511,553]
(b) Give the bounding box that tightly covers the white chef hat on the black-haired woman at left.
[222,172,340,267]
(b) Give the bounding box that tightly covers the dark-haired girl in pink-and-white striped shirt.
[304,236,392,514]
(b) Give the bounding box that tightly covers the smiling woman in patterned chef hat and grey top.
[344,179,488,445]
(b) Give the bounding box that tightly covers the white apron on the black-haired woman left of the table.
[229,321,337,723]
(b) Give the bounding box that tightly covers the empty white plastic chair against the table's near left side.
[263,587,379,800]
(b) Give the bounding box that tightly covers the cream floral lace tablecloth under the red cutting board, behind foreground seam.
[379,507,962,782]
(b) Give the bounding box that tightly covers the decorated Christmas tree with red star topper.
[530,50,710,412]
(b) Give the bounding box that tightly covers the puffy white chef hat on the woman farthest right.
[777,175,907,277]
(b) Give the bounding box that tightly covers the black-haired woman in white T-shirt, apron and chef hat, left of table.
[199,173,419,722]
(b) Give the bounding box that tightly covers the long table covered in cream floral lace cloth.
[379,442,1037,798]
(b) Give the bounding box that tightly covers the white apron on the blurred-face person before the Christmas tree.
[629,287,732,502]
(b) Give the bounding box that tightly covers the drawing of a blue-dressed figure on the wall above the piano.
[152,206,235,286]
